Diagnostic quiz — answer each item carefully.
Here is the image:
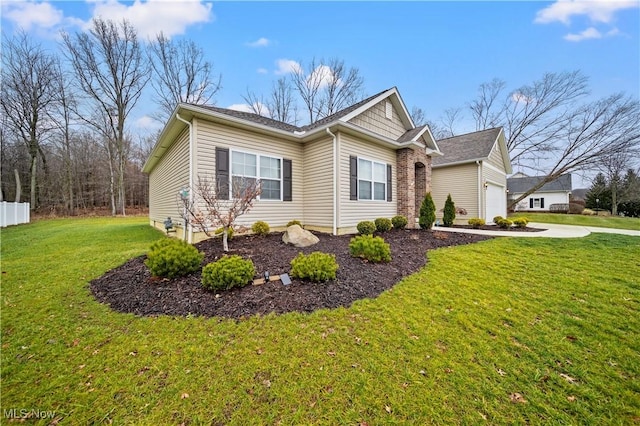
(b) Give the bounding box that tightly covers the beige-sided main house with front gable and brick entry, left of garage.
[143,87,441,242]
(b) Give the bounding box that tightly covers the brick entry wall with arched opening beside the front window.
[396,148,431,228]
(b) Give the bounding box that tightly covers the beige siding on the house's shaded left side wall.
[149,127,189,223]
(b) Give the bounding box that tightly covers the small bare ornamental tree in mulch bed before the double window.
[180,176,262,252]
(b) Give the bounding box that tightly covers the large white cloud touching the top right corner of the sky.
[534,0,640,24]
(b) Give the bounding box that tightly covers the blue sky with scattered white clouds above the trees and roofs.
[2,0,640,133]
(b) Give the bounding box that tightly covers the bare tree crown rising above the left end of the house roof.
[149,33,222,122]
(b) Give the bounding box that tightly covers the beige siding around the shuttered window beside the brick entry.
[338,134,398,231]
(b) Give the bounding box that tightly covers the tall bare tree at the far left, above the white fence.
[0,32,59,210]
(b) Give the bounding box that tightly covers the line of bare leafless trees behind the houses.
[0,19,640,214]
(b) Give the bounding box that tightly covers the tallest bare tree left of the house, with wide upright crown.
[62,19,149,215]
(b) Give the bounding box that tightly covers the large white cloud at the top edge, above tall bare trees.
[86,0,214,39]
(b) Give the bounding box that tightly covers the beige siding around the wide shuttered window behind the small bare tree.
[194,120,304,227]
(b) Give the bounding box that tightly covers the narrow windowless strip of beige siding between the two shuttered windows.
[299,138,333,229]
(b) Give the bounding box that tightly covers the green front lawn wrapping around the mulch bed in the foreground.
[1,218,640,425]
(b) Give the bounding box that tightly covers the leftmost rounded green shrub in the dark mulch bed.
[144,238,204,278]
